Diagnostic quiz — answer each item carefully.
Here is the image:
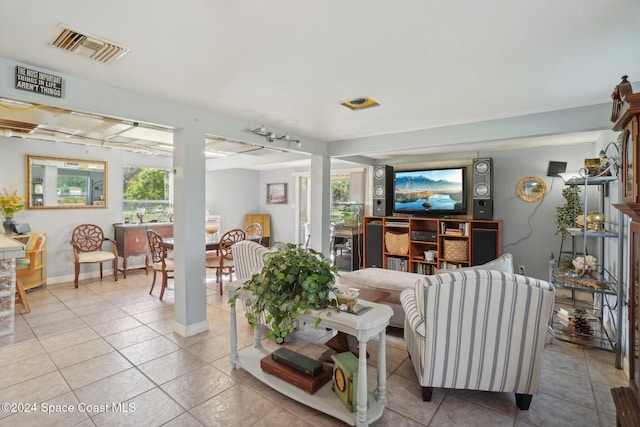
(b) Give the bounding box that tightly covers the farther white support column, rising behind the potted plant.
[310,154,331,256]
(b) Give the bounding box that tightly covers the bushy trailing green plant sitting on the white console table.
[229,243,338,344]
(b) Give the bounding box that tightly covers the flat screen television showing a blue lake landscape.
[393,166,467,217]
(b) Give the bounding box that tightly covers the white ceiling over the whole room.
[0,0,640,169]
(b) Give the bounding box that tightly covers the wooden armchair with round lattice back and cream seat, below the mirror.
[70,224,118,288]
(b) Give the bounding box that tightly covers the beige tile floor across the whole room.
[0,272,627,427]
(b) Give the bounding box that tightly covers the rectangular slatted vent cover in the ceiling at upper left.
[49,24,129,64]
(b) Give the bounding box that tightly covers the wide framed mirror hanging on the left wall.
[25,155,107,209]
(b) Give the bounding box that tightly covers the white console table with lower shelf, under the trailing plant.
[226,283,393,426]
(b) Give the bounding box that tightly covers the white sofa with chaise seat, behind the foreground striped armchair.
[336,253,513,328]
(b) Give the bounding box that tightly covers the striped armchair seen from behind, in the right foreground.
[400,270,554,410]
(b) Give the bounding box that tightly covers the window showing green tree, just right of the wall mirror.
[122,167,173,222]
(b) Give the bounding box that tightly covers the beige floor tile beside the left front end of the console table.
[162,365,236,409]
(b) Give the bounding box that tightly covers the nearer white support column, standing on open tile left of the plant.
[173,120,209,337]
